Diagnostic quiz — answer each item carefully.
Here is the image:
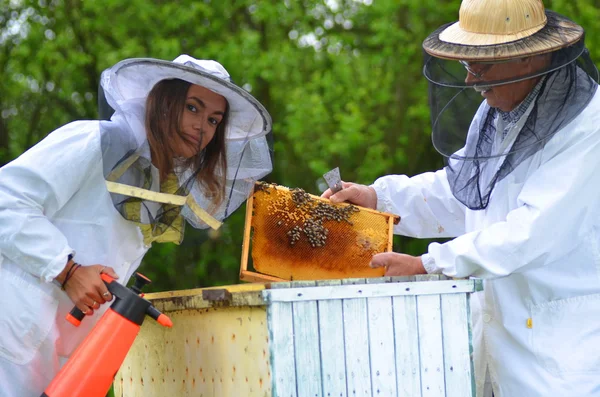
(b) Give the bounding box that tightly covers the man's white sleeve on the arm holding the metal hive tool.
[372,170,465,238]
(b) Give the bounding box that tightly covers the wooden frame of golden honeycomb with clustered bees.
[240,182,400,282]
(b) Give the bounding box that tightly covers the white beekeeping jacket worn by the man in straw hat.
[373,93,600,397]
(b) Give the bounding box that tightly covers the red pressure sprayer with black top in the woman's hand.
[41,273,173,397]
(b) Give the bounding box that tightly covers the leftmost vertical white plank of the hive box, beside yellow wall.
[267,302,298,397]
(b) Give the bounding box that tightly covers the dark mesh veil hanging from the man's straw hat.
[424,32,598,210]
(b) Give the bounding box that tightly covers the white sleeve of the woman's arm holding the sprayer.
[0,121,102,282]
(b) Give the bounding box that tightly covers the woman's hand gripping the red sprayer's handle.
[64,265,119,316]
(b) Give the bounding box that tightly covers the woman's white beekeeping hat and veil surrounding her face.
[99,56,272,243]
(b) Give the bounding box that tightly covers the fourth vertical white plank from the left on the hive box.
[342,279,372,397]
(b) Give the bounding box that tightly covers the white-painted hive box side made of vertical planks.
[263,276,480,397]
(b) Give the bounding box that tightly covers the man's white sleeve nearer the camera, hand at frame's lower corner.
[428,112,600,278]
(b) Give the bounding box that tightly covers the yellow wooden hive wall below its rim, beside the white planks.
[115,306,270,397]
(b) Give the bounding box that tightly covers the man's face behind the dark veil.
[461,57,540,112]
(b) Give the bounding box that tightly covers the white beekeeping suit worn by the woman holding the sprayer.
[0,121,149,397]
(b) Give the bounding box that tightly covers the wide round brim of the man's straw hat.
[423,10,584,62]
